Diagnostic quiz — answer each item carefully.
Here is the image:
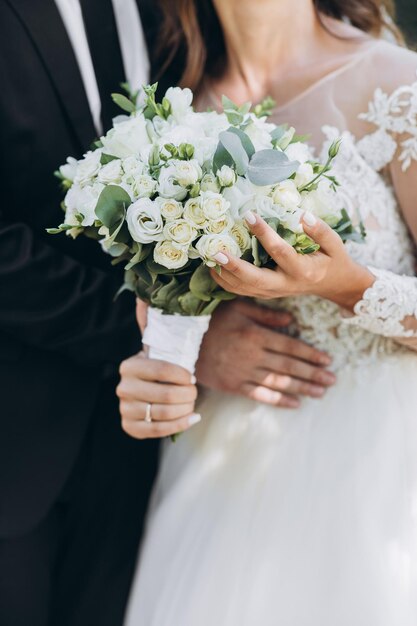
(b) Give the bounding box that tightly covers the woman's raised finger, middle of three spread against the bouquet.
[244,211,300,274]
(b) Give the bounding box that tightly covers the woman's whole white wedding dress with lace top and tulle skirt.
[126,36,417,626]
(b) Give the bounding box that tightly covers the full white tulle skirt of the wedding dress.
[125,353,417,626]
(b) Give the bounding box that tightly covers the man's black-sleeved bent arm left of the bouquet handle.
[0,221,140,365]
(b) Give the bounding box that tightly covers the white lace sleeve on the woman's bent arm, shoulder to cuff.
[345,76,417,349]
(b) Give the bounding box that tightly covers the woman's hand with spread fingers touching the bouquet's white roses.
[212,212,375,311]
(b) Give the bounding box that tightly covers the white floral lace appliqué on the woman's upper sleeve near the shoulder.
[359,82,417,172]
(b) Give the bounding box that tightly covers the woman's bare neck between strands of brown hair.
[214,0,322,101]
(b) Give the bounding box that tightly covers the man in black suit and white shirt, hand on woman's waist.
[0,0,332,626]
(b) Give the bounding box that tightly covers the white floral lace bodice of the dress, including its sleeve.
[270,44,417,369]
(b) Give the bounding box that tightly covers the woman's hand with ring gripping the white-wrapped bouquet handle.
[116,353,201,439]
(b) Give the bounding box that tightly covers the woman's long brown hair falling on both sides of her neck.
[159,0,402,91]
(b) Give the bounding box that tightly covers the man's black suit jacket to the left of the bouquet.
[0,0,176,536]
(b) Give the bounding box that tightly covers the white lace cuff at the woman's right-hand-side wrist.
[344,267,417,338]
